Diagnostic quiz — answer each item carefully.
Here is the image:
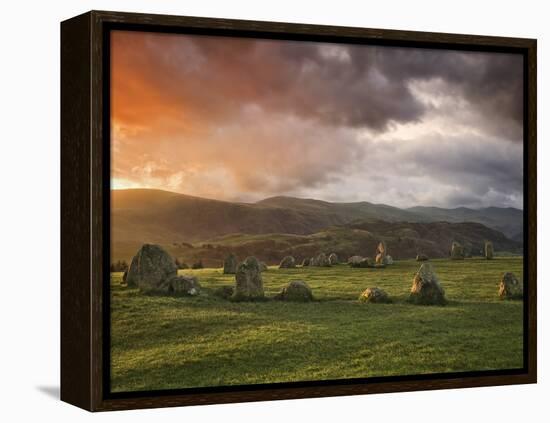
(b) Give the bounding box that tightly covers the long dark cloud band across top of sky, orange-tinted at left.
[113,33,523,135]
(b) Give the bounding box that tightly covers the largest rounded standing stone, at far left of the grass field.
[126,244,178,292]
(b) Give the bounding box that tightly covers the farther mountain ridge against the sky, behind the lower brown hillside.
[111,189,523,262]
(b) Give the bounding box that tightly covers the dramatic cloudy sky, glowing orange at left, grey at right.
[111,32,523,208]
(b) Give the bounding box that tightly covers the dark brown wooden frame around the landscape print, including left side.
[61,11,537,411]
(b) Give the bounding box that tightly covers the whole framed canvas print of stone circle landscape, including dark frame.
[61,11,536,411]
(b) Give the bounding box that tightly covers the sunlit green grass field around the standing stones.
[111,257,523,392]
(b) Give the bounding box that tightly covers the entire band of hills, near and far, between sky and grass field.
[111,189,522,262]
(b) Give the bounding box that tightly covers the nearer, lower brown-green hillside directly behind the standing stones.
[114,221,522,267]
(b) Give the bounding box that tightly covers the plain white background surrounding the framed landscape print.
[0,0,550,423]
